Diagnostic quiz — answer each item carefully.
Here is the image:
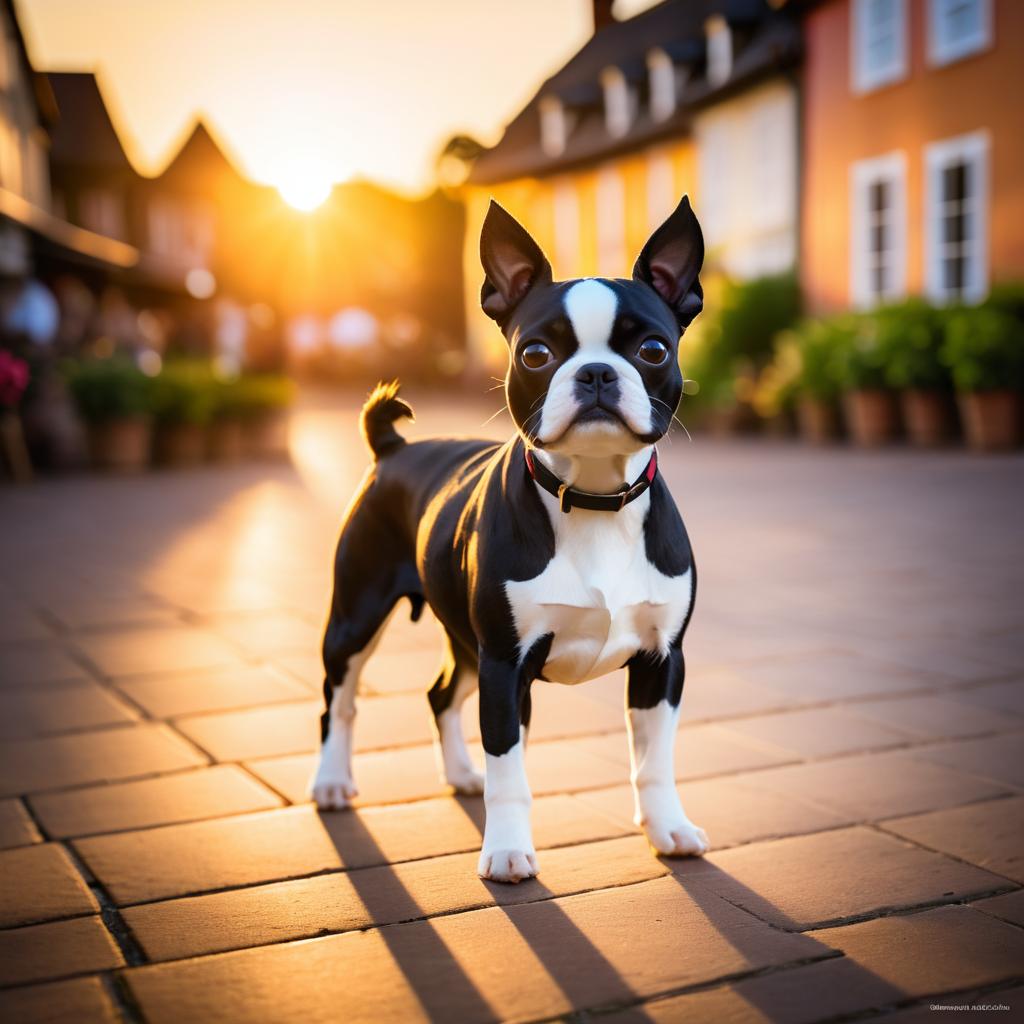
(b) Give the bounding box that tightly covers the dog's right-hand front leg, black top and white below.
[627,646,710,857]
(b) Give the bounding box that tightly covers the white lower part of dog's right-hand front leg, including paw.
[627,700,709,855]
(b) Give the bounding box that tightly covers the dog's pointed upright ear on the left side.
[480,200,551,324]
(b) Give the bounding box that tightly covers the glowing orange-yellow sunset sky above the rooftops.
[16,0,663,193]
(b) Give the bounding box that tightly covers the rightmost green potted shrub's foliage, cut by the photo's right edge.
[941,302,1024,391]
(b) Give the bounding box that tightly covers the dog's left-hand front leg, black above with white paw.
[477,651,538,882]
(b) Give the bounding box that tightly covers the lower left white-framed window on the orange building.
[850,153,906,308]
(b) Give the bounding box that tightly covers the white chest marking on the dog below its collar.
[505,495,692,683]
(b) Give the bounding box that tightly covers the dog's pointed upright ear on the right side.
[633,196,703,331]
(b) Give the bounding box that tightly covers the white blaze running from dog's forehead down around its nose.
[538,278,651,441]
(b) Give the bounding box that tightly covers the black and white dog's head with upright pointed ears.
[480,197,703,455]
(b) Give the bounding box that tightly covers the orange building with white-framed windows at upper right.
[800,0,1024,312]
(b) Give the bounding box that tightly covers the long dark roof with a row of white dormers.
[469,0,801,184]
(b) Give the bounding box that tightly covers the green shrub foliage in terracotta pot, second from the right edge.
[870,299,950,391]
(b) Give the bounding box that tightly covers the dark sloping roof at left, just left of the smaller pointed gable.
[47,72,134,172]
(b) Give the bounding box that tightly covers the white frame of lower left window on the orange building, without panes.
[850,151,906,309]
